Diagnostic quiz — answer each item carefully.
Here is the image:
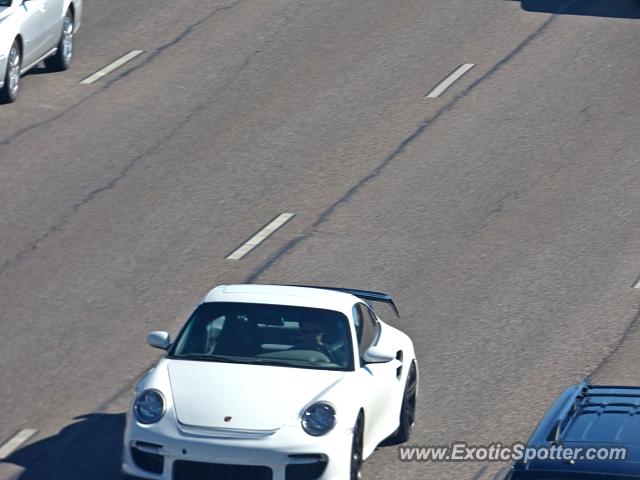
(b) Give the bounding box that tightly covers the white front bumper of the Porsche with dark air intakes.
[122,416,353,480]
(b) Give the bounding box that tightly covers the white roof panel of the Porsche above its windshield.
[202,284,359,317]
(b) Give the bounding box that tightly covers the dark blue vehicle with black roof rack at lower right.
[506,382,640,480]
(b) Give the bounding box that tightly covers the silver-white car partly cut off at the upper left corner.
[0,0,82,103]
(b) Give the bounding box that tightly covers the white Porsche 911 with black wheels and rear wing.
[122,285,418,480]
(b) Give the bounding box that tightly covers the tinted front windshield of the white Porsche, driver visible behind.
[169,302,353,370]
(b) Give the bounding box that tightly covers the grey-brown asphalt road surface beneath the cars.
[0,0,640,480]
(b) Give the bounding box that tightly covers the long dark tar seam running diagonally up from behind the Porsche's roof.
[245,7,564,283]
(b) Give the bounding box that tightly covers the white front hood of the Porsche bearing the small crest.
[168,360,344,430]
